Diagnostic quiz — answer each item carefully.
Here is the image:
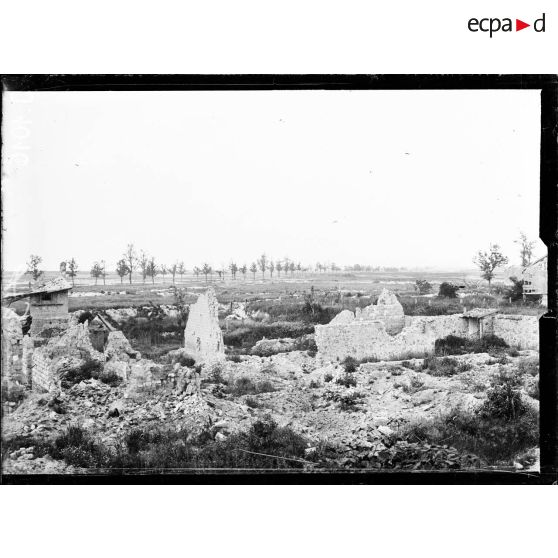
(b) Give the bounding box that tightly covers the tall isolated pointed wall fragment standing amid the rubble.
[184,287,225,362]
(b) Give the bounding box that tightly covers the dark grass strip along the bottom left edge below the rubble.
[3,419,318,472]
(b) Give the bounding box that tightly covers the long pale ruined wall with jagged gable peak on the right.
[315,290,539,361]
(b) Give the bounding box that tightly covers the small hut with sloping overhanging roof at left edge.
[3,277,72,337]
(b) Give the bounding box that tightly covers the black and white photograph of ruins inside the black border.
[1,76,555,482]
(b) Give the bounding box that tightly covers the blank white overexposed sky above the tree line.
[2,91,542,270]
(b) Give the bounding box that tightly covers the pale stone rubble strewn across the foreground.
[3,351,538,474]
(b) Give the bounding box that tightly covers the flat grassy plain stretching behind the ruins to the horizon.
[5,271,544,315]
